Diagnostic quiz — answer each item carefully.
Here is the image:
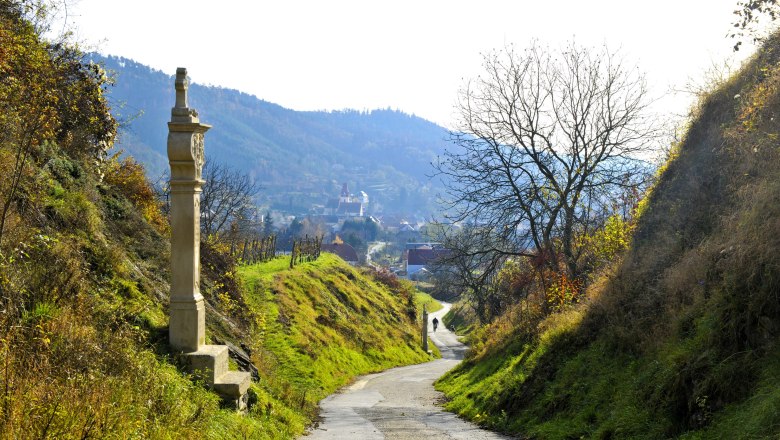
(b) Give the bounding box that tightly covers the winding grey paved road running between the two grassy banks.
[305,304,508,440]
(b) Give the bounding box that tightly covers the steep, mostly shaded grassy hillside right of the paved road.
[438,36,780,439]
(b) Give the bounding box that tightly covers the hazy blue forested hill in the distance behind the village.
[91,54,447,213]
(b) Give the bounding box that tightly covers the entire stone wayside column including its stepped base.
[168,68,251,410]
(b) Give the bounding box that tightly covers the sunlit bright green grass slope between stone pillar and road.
[238,253,430,433]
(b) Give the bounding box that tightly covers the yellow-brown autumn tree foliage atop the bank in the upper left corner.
[0,1,116,243]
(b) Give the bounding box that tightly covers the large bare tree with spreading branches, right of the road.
[435,43,658,277]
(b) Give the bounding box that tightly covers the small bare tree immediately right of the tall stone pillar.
[200,162,260,236]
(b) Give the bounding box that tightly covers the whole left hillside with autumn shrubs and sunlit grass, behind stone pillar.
[0,6,436,439]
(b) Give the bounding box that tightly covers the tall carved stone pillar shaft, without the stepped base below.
[168,68,211,353]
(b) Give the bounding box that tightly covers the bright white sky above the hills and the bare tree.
[62,0,751,128]
